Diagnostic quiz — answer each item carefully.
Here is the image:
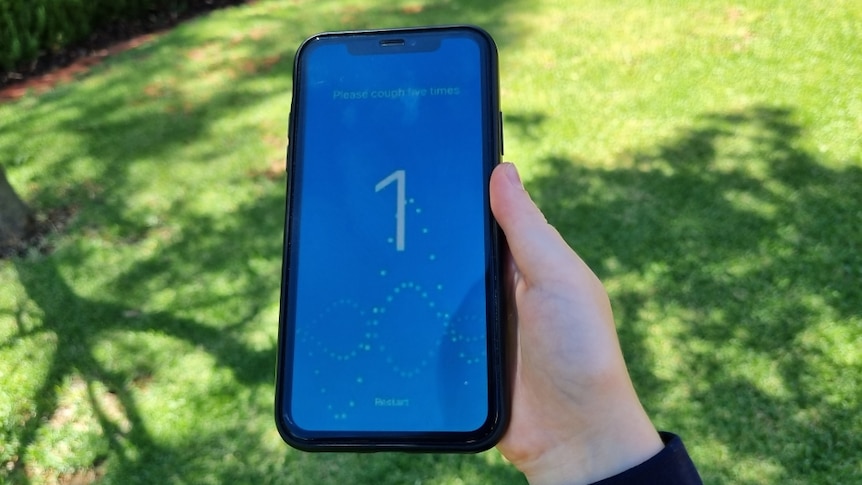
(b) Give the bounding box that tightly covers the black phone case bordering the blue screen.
[275,25,511,453]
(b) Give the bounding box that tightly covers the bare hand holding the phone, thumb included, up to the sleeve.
[490,163,663,485]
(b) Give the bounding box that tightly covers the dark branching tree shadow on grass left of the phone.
[4,192,281,482]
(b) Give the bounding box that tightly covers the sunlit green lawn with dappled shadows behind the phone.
[0,0,862,484]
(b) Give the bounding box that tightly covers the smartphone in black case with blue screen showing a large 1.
[276,26,507,452]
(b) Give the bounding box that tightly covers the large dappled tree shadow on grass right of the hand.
[528,106,862,483]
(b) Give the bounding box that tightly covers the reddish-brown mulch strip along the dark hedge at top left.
[0,0,254,102]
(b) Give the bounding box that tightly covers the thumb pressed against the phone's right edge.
[490,163,583,282]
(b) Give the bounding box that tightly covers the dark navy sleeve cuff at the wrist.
[594,432,703,485]
